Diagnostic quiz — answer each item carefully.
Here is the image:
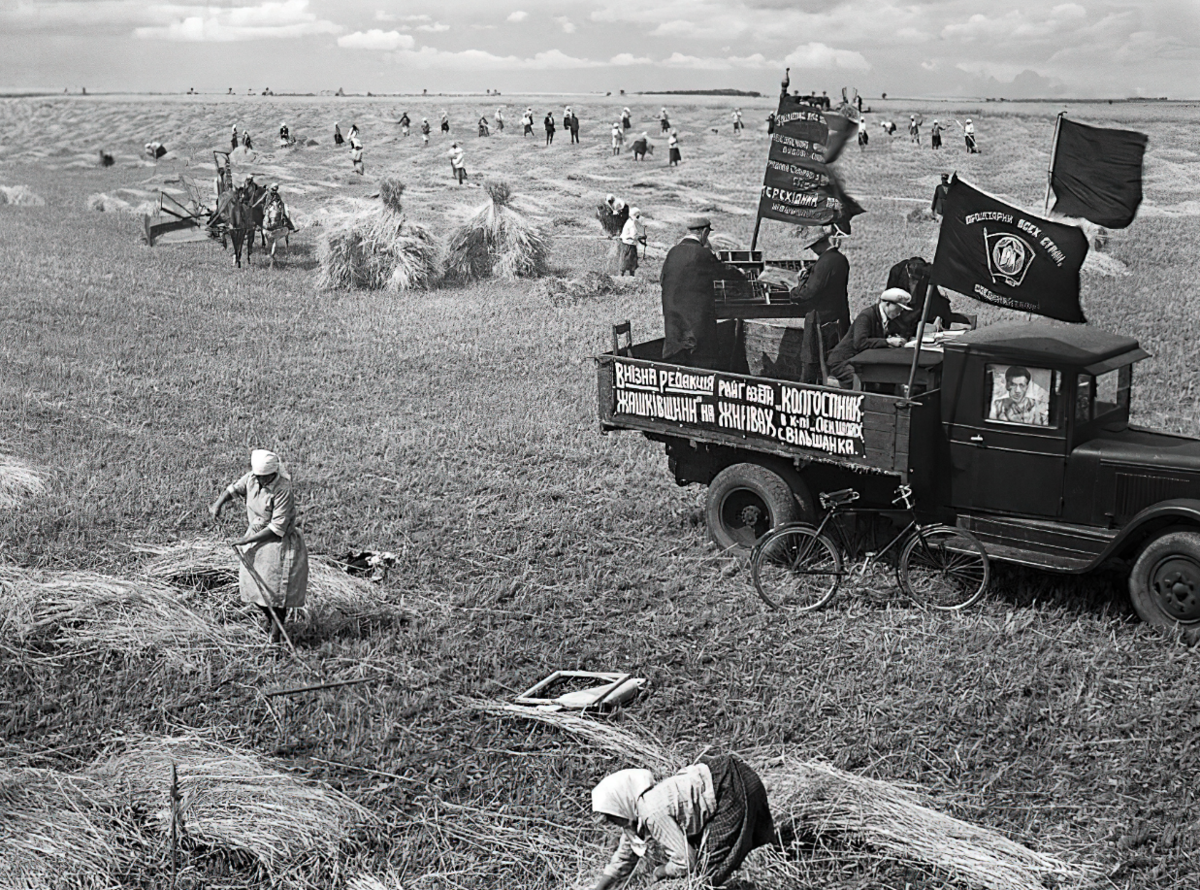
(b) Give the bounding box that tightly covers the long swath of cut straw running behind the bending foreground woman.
[457,698,1094,890]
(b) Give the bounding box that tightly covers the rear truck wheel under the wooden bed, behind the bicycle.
[704,463,799,549]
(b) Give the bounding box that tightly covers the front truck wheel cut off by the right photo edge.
[1129,531,1200,627]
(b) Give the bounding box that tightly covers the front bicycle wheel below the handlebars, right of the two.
[899,525,991,612]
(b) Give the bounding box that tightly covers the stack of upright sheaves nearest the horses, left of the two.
[317,179,438,290]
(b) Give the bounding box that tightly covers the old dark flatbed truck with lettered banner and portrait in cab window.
[596,313,1200,627]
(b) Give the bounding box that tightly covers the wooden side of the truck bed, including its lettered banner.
[596,339,932,480]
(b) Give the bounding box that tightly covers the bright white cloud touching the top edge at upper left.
[133,0,342,43]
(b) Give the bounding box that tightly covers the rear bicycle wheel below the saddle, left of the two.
[750,525,841,612]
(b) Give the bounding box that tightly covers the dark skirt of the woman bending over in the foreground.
[700,754,775,886]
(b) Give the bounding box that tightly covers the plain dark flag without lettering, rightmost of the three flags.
[1050,118,1147,229]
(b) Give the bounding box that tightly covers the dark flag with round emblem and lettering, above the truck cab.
[930,176,1087,321]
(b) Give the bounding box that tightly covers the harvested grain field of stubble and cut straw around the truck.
[0,95,1200,890]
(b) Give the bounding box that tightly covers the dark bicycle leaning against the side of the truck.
[750,485,991,612]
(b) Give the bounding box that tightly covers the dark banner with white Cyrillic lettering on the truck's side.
[613,357,866,457]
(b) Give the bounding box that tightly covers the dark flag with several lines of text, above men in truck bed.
[758,95,863,231]
